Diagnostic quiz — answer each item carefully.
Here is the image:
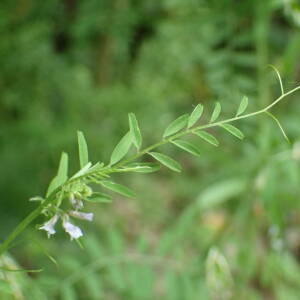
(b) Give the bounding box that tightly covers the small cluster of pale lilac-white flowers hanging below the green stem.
[39,197,94,240]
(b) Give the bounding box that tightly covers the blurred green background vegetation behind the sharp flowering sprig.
[0,0,300,300]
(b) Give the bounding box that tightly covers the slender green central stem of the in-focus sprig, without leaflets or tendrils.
[0,86,300,256]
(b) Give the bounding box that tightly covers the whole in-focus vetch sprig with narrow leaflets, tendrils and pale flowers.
[0,68,300,262]
